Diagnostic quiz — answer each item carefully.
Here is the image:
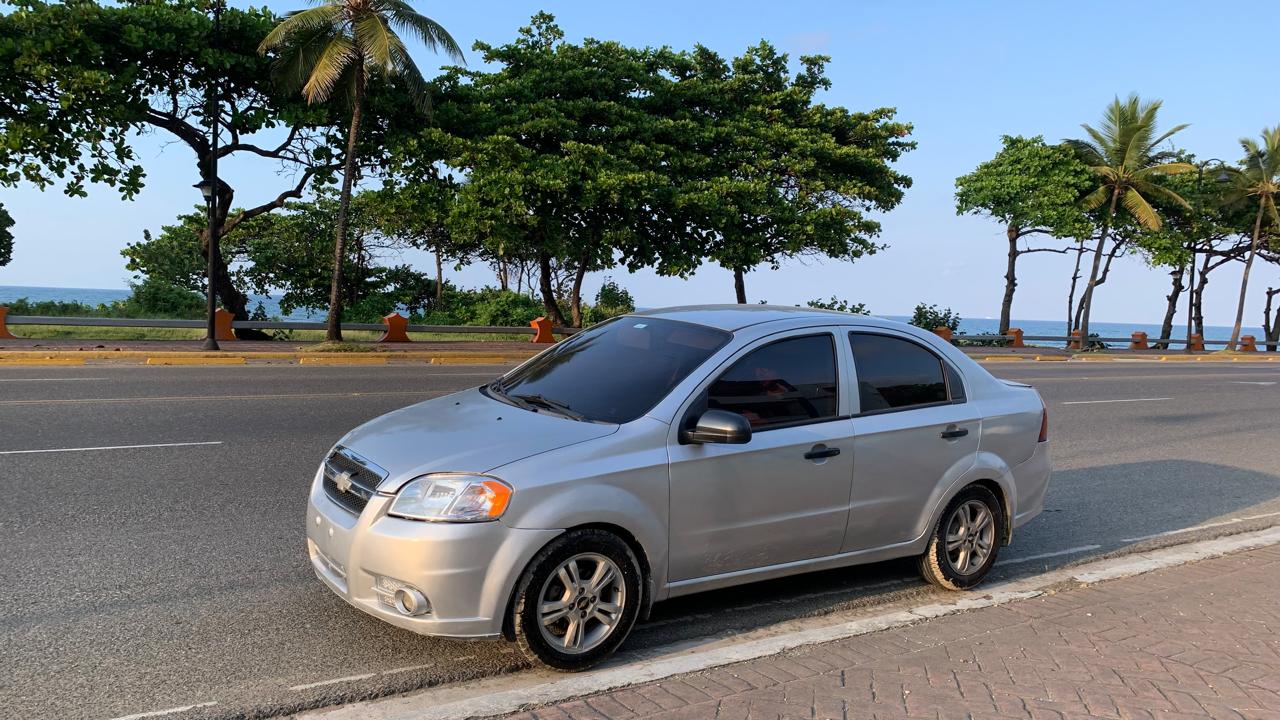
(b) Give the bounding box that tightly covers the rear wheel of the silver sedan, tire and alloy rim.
[920,486,1005,591]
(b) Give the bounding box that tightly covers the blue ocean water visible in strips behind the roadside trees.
[0,286,1262,350]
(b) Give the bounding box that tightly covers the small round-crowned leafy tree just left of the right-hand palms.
[956,135,1092,334]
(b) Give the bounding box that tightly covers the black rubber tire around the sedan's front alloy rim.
[512,529,645,673]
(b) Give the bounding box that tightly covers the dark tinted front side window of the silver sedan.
[707,334,840,429]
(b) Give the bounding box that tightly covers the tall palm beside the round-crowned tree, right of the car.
[1066,95,1196,347]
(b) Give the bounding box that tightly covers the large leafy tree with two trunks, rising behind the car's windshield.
[424,13,677,325]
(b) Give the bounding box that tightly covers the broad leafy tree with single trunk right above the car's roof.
[659,42,915,302]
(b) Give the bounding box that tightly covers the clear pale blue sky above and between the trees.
[0,0,1280,324]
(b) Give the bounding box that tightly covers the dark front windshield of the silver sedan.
[488,316,731,423]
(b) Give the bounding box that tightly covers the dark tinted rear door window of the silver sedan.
[849,333,947,413]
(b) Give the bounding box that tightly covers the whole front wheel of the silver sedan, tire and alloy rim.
[512,529,643,671]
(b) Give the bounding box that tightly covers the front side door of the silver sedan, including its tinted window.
[668,329,854,582]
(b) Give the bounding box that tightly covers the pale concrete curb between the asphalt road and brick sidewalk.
[297,527,1280,720]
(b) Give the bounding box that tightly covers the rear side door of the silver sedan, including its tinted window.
[844,331,982,552]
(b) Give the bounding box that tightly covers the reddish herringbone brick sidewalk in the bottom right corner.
[520,547,1280,720]
